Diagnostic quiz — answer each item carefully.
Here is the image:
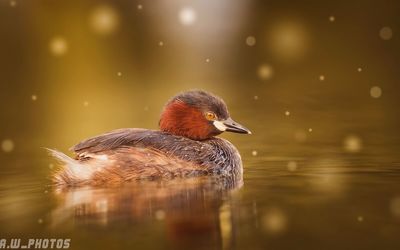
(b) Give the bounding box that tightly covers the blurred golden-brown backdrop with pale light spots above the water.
[0,0,400,154]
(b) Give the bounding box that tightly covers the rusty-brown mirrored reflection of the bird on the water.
[51,177,243,248]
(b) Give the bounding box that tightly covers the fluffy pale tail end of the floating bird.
[46,148,93,185]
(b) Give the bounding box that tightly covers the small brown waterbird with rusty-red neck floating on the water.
[50,91,250,185]
